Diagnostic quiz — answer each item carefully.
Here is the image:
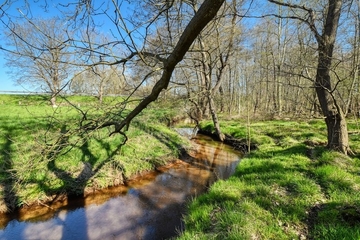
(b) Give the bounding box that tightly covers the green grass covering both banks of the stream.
[0,95,360,239]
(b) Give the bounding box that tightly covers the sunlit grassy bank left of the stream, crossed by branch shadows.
[0,95,187,212]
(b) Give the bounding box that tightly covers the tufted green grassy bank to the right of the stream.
[179,120,360,239]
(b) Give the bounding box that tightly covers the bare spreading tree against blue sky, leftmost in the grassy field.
[5,18,71,107]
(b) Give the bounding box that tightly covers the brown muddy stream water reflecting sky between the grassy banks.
[0,136,240,240]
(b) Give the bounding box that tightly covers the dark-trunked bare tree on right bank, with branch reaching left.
[269,0,350,154]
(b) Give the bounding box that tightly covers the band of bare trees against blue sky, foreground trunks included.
[1,0,360,156]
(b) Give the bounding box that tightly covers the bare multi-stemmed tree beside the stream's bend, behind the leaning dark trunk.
[153,1,237,141]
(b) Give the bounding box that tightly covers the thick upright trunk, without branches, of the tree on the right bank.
[315,0,349,154]
